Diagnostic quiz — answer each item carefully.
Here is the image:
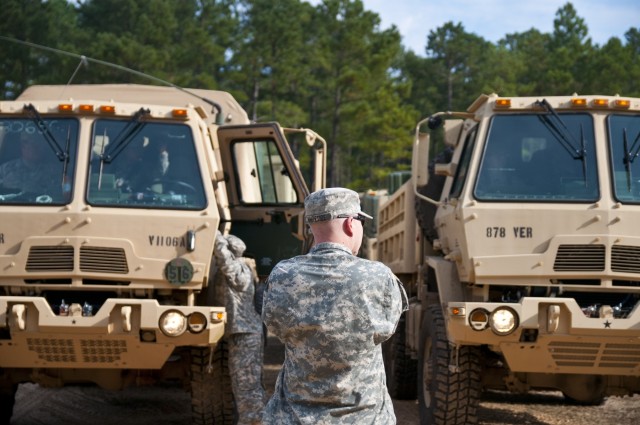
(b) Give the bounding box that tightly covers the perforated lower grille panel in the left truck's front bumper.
[27,338,127,363]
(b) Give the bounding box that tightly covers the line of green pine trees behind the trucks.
[0,0,640,190]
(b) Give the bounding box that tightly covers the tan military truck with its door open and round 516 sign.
[0,85,325,424]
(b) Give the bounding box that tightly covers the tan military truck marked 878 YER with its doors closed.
[375,94,640,424]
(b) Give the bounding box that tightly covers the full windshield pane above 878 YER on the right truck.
[474,114,596,202]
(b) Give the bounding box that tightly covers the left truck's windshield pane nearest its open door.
[87,120,206,210]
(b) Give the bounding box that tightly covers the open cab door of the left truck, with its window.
[217,123,309,276]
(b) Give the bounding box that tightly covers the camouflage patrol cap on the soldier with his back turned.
[304,187,373,223]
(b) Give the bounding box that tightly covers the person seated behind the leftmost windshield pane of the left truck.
[0,131,62,195]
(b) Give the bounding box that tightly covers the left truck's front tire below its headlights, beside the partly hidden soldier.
[191,341,236,425]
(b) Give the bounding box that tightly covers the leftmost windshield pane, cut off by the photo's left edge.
[0,117,78,205]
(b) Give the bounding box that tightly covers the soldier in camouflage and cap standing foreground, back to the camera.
[262,188,407,425]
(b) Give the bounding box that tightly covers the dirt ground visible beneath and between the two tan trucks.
[11,341,640,425]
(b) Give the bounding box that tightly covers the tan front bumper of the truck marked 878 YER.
[446,297,640,376]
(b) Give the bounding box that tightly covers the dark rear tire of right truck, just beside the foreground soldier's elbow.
[382,314,418,400]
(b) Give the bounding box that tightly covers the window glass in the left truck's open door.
[232,140,298,204]
